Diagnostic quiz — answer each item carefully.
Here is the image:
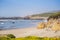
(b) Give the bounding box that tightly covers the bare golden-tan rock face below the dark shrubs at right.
[37,19,60,31]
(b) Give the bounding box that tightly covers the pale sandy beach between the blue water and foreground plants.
[0,27,60,38]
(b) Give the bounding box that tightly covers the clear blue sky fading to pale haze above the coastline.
[0,0,60,17]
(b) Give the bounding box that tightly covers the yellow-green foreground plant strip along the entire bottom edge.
[0,36,60,40]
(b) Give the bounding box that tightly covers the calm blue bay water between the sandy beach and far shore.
[0,20,45,29]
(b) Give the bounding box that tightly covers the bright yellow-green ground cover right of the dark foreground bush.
[15,36,60,40]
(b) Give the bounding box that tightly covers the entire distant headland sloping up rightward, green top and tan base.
[24,11,60,20]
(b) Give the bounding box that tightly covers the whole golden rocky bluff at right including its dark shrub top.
[37,12,60,31]
